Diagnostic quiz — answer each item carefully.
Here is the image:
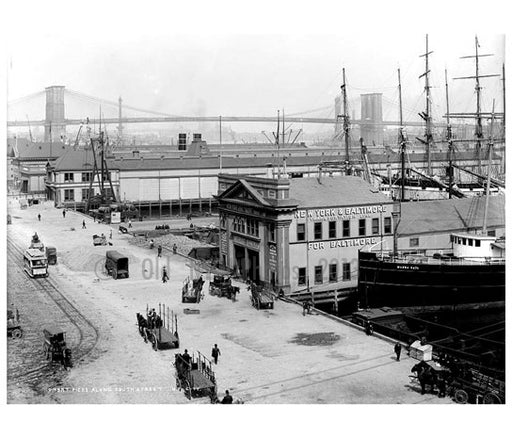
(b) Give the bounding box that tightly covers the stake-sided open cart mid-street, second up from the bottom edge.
[137,304,180,351]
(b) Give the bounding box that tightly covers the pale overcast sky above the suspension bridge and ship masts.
[3,1,505,126]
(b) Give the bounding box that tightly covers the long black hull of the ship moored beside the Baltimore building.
[358,252,505,311]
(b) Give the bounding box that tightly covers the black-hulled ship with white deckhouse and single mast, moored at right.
[358,93,505,312]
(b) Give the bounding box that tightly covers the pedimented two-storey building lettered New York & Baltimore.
[217,174,393,304]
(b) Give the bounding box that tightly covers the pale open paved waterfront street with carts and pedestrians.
[7,201,452,404]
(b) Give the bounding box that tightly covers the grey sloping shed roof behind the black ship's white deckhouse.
[398,195,505,236]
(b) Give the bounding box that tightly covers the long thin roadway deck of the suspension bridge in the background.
[7,116,426,128]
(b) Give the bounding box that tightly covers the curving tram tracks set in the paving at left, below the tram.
[7,237,100,382]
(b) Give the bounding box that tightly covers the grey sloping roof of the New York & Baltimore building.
[290,176,392,208]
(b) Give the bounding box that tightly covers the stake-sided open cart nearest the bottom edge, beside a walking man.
[174,352,217,403]
